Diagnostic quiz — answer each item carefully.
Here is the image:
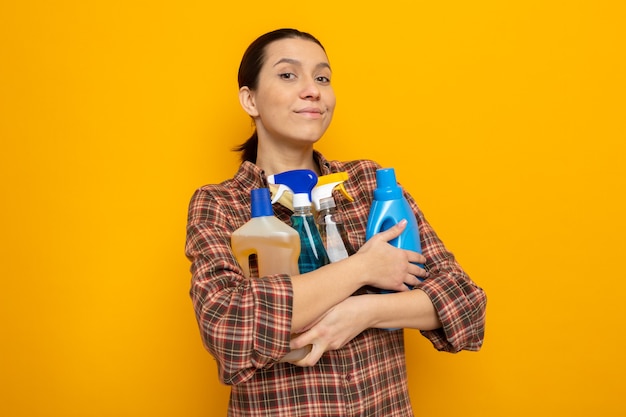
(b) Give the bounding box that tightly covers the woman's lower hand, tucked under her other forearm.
[281,296,368,366]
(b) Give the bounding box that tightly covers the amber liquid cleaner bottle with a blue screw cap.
[231,188,300,278]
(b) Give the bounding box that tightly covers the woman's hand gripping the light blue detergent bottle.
[353,220,428,291]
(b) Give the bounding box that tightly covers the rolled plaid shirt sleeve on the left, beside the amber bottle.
[185,187,293,385]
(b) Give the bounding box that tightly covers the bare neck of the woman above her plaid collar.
[256,143,320,175]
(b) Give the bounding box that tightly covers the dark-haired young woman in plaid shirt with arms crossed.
[186,29,486,417]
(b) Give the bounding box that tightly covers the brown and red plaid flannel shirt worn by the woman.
[186,152,486,417]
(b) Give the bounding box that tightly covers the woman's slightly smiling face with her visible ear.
[240,38,335,146]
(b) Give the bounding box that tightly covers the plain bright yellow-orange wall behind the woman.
[0,0,626,417]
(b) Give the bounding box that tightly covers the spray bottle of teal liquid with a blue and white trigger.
[267,169,330,274]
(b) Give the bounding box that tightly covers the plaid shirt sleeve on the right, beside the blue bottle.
[407,194,487,353]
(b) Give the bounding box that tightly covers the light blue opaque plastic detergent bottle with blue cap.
[365,168,424,280]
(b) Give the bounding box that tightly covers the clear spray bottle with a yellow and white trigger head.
[311,172,356,262]
